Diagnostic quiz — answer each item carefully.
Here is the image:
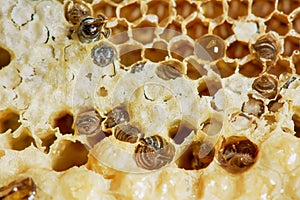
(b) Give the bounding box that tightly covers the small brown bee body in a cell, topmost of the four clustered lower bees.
[104,106,130,128]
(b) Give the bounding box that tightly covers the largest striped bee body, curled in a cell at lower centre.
[134,135,175,170]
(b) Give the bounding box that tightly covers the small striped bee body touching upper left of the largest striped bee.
[114,124,142,143]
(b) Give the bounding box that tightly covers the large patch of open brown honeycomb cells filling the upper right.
[59,0,300,103]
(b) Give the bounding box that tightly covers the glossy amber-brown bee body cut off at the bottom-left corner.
[0,177,36,200]
